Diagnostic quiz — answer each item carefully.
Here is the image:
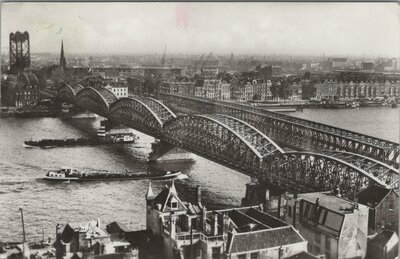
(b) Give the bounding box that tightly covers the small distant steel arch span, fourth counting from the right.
[76,87,118,117]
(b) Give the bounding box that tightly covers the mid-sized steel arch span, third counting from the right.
[110,97,164,137]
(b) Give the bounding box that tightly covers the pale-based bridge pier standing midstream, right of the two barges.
[149,140,193,162]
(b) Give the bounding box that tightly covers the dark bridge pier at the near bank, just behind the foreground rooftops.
[241,181,285,218]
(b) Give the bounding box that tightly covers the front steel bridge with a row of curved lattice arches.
[56,87,398,199]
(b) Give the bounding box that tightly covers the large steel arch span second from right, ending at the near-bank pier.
[163,114,283,176]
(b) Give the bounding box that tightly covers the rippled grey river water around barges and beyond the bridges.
[0,108,399,241]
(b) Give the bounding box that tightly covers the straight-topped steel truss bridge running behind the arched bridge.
[161,94,400,168]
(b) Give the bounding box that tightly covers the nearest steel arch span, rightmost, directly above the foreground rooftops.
[259,152,390,200]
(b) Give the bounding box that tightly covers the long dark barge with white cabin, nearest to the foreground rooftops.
[44,167,182,182]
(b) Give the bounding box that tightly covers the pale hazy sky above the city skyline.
[1,2,400,57]
